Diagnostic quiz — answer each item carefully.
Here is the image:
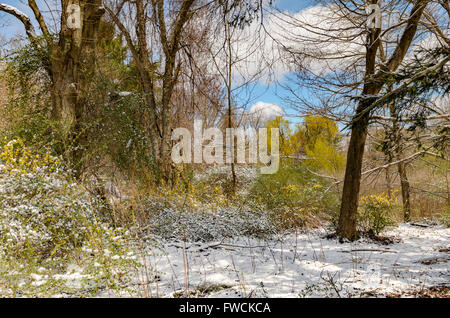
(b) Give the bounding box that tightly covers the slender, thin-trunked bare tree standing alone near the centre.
[205,0,267,194]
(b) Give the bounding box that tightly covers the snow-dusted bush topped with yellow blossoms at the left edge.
[0,141,101,259]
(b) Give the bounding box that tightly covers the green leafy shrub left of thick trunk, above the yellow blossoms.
[0,37,70,155]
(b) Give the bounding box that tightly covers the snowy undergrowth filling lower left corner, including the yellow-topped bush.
[0,140,138,297]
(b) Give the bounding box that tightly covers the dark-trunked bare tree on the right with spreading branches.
[278,0,448,240]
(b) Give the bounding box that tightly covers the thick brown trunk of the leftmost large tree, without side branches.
[58,0,104,177]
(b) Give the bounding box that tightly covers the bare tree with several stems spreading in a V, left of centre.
[106,0,205,181]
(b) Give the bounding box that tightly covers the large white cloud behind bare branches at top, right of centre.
[204,5,365,85]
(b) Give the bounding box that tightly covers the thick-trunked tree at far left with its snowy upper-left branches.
[0,0,104,174]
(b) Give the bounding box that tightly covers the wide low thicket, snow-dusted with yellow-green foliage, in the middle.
[121,166,338,242]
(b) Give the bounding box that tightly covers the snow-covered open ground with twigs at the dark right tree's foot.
[129,224,450,297]
